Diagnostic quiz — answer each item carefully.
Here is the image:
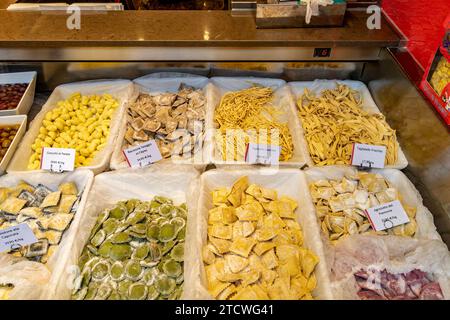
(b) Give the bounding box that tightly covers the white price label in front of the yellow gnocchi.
[41,148,75,172]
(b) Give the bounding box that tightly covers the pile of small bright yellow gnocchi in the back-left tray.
[28,93,119,170]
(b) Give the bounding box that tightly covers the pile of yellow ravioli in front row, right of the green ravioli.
[202,176,319,300]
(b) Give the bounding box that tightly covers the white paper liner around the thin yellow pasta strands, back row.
[207,77,308,168]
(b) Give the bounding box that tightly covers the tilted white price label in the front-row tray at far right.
[366,200,409,231]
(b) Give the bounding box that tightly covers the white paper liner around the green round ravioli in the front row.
[42,164,198,299]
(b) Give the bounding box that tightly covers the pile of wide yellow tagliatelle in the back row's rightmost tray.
[297,84,398,166]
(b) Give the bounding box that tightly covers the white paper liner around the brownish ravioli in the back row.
[110,73,210,171]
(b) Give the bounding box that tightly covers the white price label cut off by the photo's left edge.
[0,223,38,252]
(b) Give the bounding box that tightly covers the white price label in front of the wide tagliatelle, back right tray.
[351,143,386,168]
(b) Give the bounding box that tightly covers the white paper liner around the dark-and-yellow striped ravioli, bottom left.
[0,169,94,299]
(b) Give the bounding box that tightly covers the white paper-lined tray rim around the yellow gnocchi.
[7,80,133,174]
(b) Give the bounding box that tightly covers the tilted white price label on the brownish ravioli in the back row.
[123,140,162,168]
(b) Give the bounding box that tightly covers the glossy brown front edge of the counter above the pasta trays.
[0,46,380,62]
